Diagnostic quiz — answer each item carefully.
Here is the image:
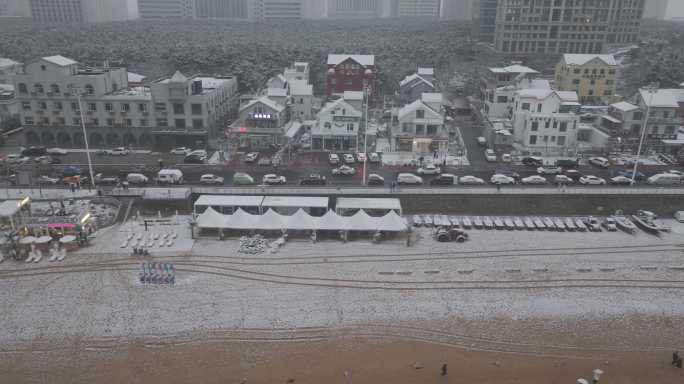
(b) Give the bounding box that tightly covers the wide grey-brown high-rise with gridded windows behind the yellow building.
[494,0,644,53]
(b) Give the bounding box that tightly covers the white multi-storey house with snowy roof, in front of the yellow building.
[512,89,580,156]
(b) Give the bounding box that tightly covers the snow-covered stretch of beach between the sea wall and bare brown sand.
[0,217,684,344]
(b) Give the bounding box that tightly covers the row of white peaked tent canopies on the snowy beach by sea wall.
[197,207,408,232]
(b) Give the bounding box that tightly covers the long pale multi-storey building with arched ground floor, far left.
[14,56,238,148]
